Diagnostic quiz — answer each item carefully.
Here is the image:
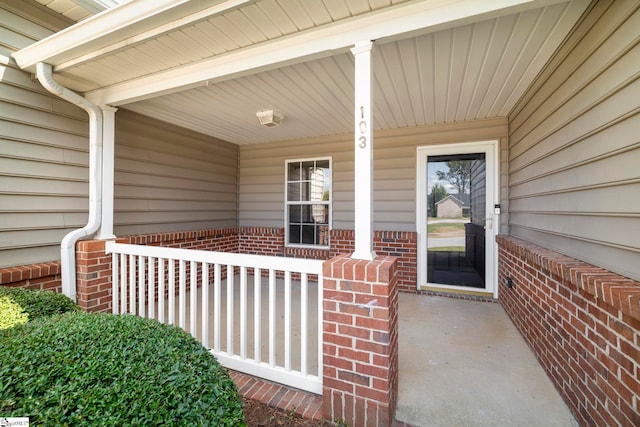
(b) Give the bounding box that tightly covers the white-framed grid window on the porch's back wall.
[285,158,331,246]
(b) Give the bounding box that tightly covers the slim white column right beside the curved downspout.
[96,105,118,240]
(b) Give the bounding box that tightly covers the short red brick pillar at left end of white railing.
[76,239,128,313]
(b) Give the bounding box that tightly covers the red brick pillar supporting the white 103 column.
[323,255,398,427]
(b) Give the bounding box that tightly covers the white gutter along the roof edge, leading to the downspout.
[12,0,189,72]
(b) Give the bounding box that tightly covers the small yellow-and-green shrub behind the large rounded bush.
[0,286,80,329]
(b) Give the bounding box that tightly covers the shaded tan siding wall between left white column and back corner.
[114,109,238,235]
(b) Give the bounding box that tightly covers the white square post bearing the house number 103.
[351,41,376,260]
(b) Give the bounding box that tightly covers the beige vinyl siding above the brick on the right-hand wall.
[509,1,640,279]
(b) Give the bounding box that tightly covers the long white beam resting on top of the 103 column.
[86,0,566,106]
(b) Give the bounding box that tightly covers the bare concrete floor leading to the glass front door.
[396,294,578,427]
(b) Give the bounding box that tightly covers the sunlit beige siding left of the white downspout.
[0,1,84,267]
